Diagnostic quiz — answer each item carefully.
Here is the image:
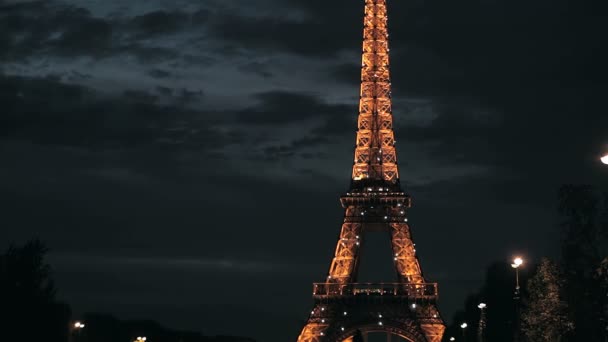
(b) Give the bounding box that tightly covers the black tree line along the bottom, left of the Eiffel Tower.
[0,240,255,342]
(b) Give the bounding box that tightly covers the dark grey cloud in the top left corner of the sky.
[0,1,206,63]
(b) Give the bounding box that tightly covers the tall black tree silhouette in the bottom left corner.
[0,240,70,342]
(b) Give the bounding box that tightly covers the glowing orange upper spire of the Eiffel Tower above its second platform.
[352,0,399,189]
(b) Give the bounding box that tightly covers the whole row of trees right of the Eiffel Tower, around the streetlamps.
[444,185,608,342]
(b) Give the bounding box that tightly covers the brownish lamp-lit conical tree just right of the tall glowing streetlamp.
[521,258,574,342]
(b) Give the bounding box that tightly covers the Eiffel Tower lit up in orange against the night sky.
[298,0,445,342]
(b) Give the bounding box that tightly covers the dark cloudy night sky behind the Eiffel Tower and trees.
[0,0,608,342]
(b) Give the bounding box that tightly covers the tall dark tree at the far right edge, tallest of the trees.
[559,185,608,341]
